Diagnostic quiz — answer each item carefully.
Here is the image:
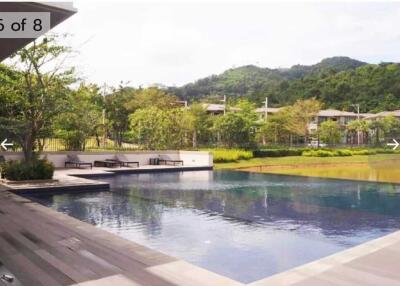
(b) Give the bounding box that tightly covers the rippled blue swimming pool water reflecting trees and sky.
[29,171,400,283]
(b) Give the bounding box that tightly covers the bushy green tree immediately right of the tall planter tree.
[55,83,101,151]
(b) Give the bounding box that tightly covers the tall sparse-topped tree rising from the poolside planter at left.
[0,35,75,162]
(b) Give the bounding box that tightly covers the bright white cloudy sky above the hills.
[50,0,400,86]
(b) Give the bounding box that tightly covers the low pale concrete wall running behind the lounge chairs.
[0,151,213,168]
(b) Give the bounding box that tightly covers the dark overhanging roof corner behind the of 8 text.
[0,2,77,62]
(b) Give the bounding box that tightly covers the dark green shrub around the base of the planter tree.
[1,159,54,181]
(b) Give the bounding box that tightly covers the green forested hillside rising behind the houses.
[170,57,400,112]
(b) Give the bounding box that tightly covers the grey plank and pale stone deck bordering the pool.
[0,167,400,286]
